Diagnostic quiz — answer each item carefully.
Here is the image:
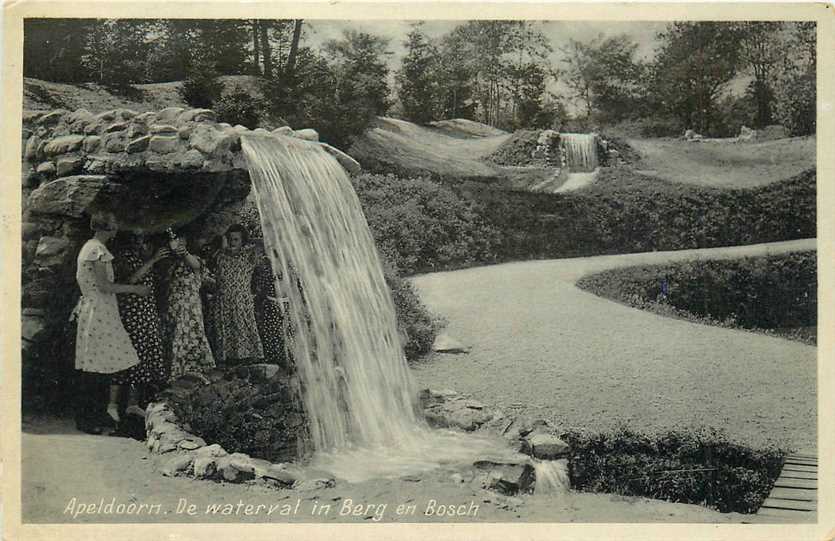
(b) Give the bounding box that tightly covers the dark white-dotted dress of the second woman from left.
[112,251,167,385]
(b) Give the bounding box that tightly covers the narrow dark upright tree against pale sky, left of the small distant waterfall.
[395,22,439,124]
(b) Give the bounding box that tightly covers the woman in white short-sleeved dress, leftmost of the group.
[74,213,150,433]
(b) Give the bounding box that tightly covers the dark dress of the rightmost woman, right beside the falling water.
[252,260,286,366]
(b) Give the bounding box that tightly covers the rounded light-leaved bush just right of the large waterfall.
[353,173,498,274]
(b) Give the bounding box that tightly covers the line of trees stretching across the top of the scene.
[24,19,817,137]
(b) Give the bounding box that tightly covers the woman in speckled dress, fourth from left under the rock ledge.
[215,224,264,365]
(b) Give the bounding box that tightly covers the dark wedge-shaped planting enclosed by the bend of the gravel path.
[577,252,818,342]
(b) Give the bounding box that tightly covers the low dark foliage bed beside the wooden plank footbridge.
[562,428,786,513]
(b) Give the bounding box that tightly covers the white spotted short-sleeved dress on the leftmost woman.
[75,238,139,374]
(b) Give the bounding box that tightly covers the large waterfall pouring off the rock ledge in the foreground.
[241,135,509,481]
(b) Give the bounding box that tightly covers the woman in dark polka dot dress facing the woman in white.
[114,231,171,416]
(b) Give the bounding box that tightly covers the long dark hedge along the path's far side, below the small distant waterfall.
[455,167,817,263]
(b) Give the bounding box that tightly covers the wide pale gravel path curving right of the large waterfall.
[413,239,817,450]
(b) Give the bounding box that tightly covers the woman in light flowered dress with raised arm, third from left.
[165,230,215,380]
